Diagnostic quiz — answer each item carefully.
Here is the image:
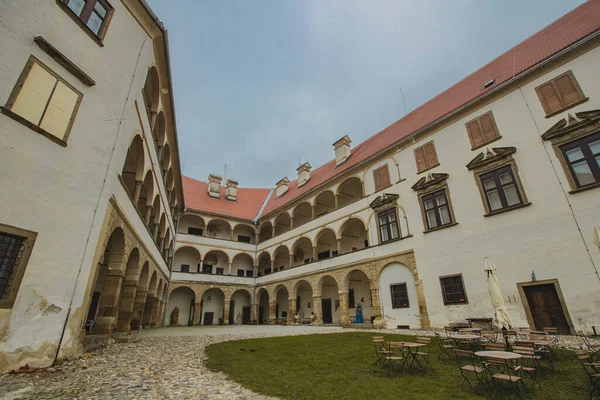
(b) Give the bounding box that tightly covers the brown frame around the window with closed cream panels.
[0,55,83,147]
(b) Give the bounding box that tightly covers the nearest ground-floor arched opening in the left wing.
[86,228,125,333]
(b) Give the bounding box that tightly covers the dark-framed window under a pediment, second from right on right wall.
[480,165,523,212]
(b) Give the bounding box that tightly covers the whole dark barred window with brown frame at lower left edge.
[0,224,37,308]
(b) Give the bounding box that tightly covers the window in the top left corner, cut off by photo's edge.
[58,0,114,40]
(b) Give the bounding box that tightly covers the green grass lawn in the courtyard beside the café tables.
[206,332,588,400]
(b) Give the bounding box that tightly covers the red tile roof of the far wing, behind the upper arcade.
[183,176,271,220]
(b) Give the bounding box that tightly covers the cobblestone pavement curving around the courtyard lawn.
[0,326,592,400]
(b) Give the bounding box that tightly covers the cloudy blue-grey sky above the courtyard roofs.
[147,0,583,187]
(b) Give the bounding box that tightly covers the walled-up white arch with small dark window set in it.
[379,262,421,329]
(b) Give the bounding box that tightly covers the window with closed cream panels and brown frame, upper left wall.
[2,56,83,146]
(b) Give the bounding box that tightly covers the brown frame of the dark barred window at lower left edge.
[0,224,37,309]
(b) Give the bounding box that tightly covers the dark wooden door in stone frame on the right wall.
[523,283,571,335]
